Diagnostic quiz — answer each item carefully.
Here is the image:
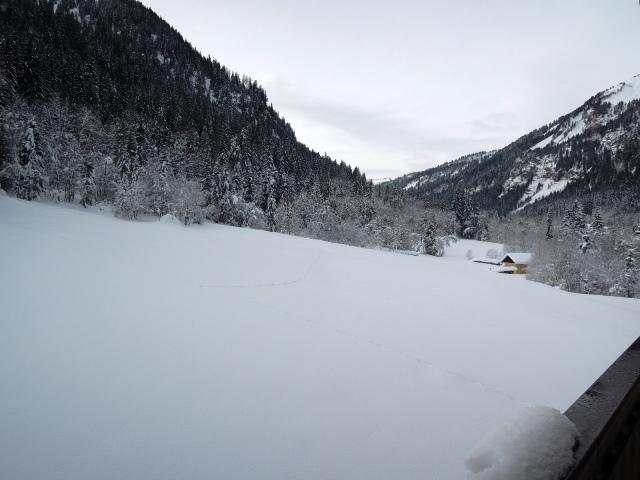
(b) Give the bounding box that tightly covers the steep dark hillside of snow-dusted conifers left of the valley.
[0,0,371,230]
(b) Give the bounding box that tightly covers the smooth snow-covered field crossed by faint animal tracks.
[0,196,640,480]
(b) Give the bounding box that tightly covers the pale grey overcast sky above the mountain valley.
[143,0,640,178]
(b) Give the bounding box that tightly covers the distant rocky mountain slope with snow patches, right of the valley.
[392,76,640,213]
